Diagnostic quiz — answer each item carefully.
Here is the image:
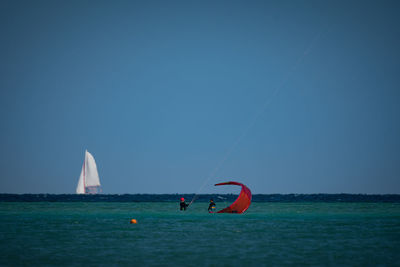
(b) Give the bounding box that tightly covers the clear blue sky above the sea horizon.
[0,0,400,194]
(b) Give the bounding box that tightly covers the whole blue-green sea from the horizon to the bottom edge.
[0,194,400,266]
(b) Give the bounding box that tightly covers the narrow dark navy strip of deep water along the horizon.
[0,194,400,203]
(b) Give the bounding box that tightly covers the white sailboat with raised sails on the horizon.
[76,150,101,194]
